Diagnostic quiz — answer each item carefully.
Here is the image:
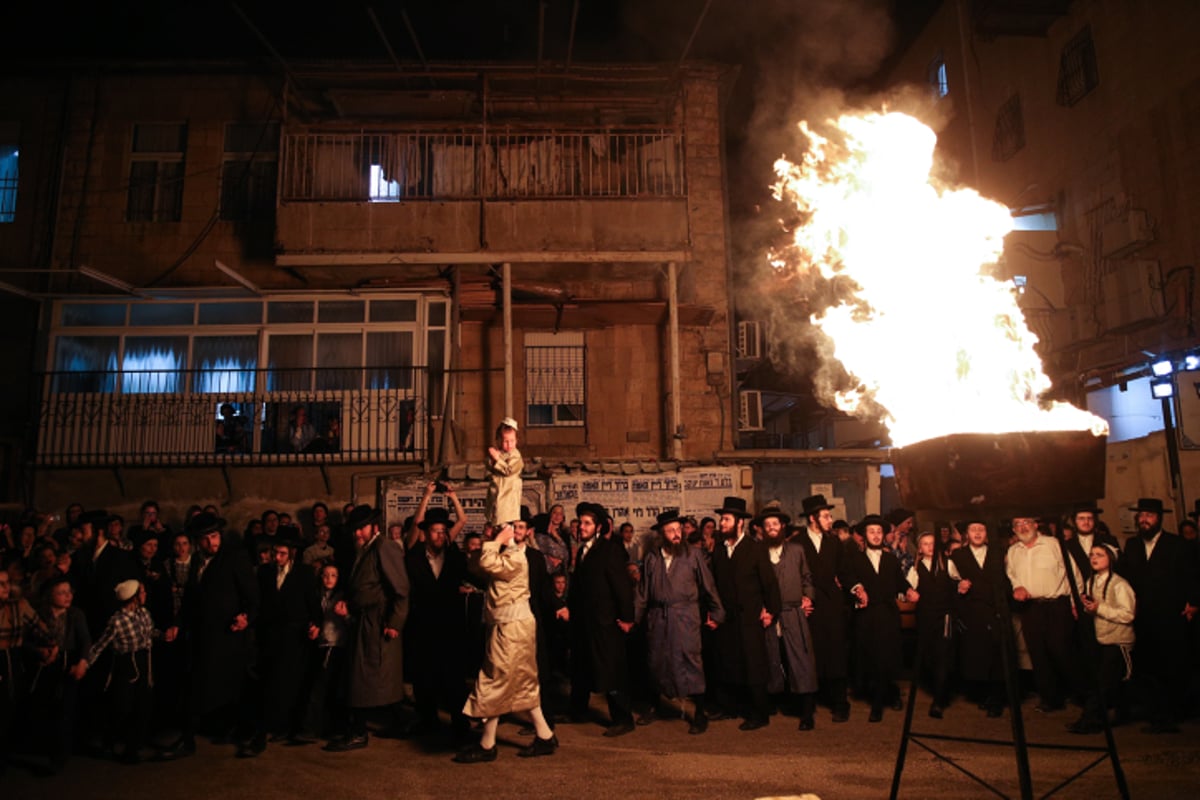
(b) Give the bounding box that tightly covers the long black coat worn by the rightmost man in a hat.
[1122,530,1200,675]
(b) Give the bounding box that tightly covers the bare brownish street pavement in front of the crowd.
[0,694,1200,800]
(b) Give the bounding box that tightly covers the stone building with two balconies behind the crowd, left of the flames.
[0,61,736,527]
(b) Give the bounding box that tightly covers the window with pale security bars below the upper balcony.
[524,332,587,427]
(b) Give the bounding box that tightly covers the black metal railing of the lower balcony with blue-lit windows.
[36,367,443,467]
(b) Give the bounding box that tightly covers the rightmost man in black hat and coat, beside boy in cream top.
[1121,498,1200,734]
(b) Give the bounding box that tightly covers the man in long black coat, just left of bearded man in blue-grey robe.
[568,503,634,736]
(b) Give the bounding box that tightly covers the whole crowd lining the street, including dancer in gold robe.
[0,484,1200,770]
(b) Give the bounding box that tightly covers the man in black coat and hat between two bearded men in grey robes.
[713,497,782,730]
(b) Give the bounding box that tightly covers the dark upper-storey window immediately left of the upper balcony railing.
[221,122,280,222]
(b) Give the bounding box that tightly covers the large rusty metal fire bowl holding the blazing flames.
[892,431,1108,513]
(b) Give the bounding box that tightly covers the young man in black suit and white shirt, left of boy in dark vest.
[851,515,911,722]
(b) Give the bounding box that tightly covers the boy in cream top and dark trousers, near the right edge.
[1067,542,1136,734]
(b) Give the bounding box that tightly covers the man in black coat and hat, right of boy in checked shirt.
[164,512,259,758]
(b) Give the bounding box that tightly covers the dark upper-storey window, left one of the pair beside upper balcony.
[125,124,187,222]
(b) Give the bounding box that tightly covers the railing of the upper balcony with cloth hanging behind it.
[280,128,686,203]
